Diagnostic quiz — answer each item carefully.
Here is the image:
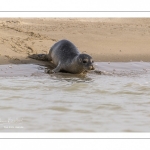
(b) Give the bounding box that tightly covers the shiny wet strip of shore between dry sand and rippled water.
[0,62,150,78]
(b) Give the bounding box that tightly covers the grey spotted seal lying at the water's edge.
[29,40,94,74]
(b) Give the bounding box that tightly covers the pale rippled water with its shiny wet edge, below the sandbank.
[0,62,150,132]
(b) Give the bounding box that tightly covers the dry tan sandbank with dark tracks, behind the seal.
[0,18,150,64]
